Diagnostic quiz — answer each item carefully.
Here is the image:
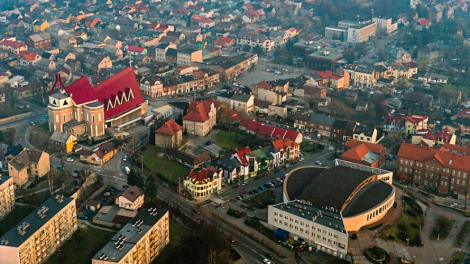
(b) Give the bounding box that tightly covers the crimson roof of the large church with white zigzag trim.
[61,67,144,119]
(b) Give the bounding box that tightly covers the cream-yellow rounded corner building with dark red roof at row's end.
[183,166,223,198]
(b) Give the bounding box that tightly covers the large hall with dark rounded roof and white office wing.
[268,160,395,259]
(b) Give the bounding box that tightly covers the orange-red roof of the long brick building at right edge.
[397,143,470,171]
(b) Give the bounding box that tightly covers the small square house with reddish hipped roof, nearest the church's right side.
[155,119,183,148]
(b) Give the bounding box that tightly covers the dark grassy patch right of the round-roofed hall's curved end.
[379,199,423,245]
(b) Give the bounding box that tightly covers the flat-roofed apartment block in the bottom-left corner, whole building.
[0,194,77,264]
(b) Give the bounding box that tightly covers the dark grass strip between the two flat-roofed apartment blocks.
[46,227,115,264]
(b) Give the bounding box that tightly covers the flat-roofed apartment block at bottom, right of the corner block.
[92,208,170,264]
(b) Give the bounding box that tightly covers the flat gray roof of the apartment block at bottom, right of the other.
[92,208,168,263]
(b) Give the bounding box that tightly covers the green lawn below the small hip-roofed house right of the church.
[134,145,189,184]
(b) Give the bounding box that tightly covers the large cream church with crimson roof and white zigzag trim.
[47,67,147,137]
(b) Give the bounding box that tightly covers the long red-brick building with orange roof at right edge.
[396,143,470,196]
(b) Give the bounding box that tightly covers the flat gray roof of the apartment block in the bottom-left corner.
[0,196,75,247]
